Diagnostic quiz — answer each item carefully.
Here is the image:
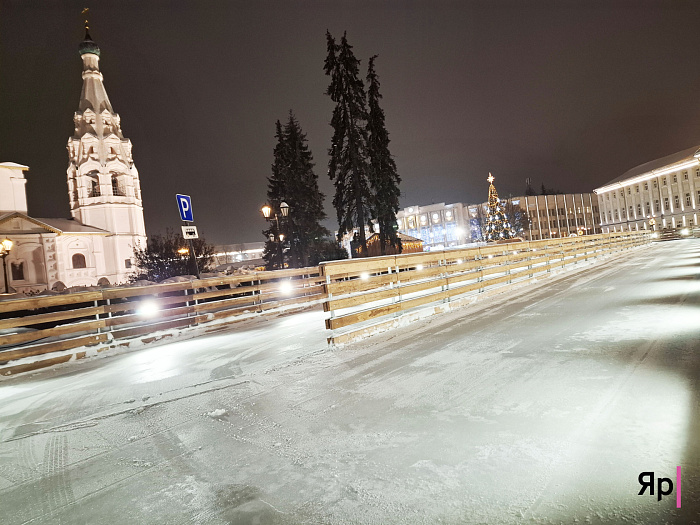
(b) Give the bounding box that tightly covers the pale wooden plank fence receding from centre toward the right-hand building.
[321,232,650,344]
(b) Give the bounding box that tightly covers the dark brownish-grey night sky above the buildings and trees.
[0,0,700,243]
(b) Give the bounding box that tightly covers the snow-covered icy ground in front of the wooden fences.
[0,239,700,525]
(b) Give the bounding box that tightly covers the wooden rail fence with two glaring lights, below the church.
[0,267,324,374]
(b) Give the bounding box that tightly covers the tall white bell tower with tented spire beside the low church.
[68,22,146,284]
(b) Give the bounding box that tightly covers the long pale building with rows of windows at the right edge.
[595,146,700,233]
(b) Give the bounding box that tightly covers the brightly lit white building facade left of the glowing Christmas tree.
[396,202,472,251]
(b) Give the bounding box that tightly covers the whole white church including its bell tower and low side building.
[0,26,146,292]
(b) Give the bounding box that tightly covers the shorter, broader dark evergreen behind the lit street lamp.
[263,111,329,268]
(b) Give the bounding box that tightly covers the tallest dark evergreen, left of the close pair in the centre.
[324,32,373,256]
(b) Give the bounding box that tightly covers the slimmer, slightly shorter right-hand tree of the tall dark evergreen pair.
[367,55,401,255]
